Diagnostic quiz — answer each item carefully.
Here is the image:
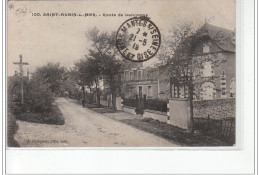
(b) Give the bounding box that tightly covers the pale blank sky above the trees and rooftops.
[7,0,236,76]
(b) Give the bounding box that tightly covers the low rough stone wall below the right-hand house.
[193,98,236,120]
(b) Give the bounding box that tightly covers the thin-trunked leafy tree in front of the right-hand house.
[164,23,229,133]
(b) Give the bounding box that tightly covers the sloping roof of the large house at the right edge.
[198,23,236,52]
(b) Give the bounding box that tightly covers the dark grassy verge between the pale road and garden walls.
[91,107,232,147]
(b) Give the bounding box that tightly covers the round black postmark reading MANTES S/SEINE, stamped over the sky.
[116,17,161,62]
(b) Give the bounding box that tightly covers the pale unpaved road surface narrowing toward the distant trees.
[15,98,177,147]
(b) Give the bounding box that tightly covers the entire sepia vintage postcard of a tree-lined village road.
[6,0,238,148]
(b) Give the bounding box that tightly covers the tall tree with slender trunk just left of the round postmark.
[86,28,121,110]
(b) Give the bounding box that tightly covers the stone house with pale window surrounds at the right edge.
[172,23,236,100]
